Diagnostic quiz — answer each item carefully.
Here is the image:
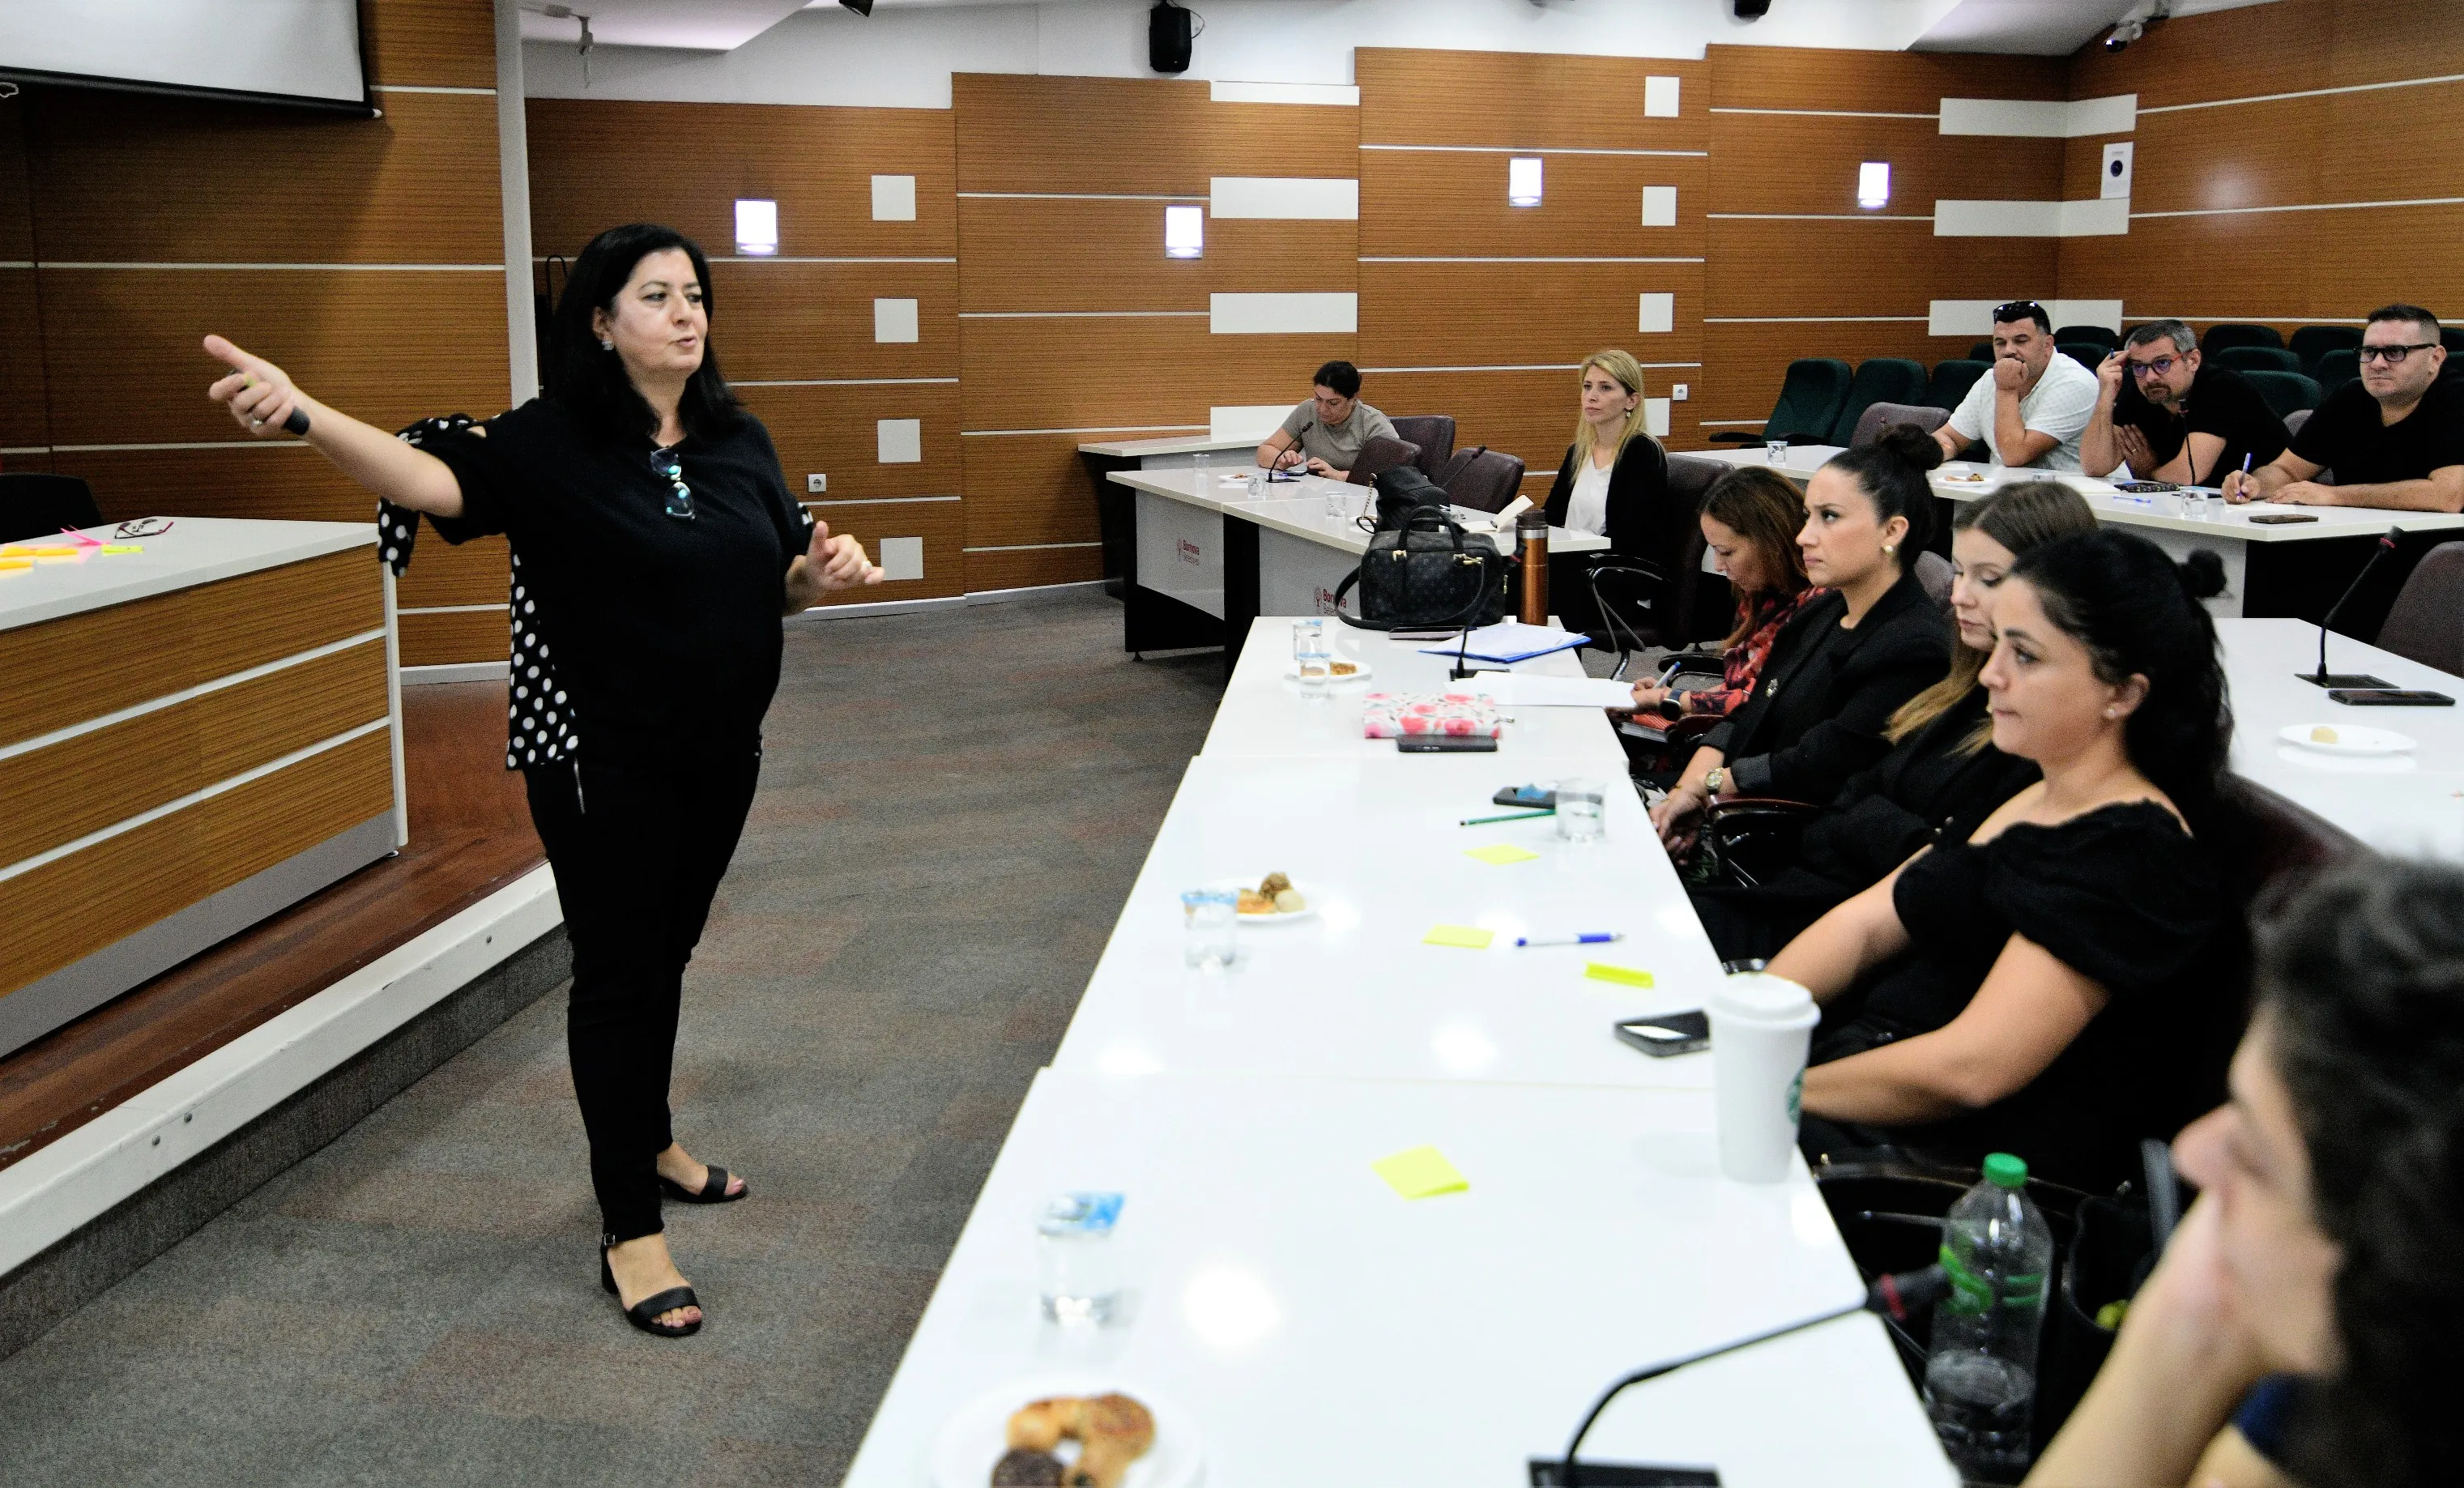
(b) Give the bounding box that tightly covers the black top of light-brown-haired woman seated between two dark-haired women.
[1797,688,2043,899]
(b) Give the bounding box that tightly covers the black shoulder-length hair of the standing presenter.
[539,222,744,443]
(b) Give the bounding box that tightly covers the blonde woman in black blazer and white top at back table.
[1545,350,1693,631]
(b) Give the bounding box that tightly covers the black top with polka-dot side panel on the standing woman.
[419,399,808,766]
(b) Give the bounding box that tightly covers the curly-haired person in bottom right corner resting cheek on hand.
[2028,859,2464,1488]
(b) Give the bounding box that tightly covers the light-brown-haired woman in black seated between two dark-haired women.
[1688,480,2097,961]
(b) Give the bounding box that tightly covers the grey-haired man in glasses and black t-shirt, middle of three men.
[2079,320,2284,485]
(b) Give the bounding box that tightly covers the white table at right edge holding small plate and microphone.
[2218,620,2464,862]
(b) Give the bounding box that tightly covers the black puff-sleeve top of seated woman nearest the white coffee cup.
[1816,800,2240,1192]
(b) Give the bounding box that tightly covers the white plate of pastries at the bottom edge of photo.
[927,1375,1208,1488]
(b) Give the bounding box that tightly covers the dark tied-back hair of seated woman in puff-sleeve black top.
[2010,527,2232,808]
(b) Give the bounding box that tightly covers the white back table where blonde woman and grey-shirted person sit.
[1106,458,1609,653]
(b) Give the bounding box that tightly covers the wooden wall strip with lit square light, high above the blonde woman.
[1360,151,1707,258]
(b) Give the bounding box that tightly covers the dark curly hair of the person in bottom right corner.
[2252,857,2464,1488]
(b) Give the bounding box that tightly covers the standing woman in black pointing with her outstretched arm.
[204,224,882,1337]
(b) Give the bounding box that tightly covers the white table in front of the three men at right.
[1695,443,2464,618]
